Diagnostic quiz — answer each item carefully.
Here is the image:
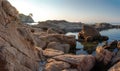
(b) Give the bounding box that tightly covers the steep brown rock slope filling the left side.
[0,0,40,71]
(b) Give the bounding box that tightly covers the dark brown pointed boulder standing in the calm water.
[78,25,108,41]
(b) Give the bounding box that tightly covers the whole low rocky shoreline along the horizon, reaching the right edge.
[32,20,120,34]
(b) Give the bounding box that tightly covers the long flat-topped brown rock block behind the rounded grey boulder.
[34,33,76,49]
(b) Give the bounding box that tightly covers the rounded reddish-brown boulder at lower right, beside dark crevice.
[96,46,113,65]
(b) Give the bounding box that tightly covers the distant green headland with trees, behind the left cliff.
[19,14,34,23]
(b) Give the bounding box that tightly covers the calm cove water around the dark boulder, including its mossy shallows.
[66,29,120,55]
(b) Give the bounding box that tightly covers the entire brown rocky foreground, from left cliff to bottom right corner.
[0,0,120,71]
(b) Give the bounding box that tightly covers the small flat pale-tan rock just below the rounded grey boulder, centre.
[43,49,64,57]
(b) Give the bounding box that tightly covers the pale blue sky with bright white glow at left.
[8,0,120,23]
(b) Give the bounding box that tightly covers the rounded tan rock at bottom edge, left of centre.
[44,60,70,71]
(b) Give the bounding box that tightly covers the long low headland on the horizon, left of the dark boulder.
[33,20,83,33]
